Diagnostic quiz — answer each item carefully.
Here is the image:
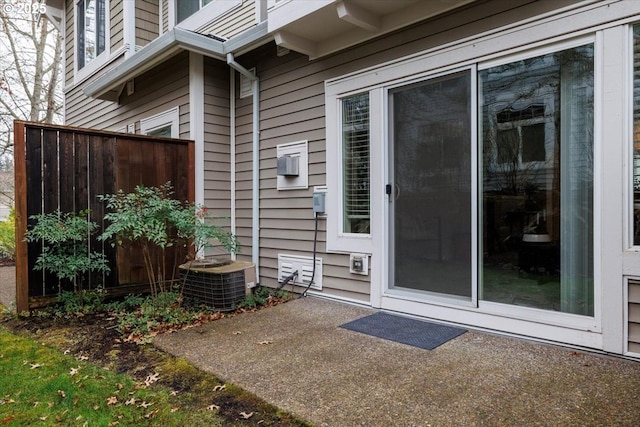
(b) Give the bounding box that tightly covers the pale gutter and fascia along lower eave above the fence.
[84,28,225,98]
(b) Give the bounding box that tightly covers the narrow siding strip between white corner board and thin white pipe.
[204,58,232,255]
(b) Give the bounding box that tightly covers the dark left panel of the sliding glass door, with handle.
[388,71,473,300]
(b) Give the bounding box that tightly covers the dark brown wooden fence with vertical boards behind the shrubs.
[14,121,195,312]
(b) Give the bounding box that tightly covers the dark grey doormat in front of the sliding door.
[340,313,466,350]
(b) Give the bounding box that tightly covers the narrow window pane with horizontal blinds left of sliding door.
[342,94,370,234]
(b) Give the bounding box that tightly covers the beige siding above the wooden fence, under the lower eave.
[66,53,189,134]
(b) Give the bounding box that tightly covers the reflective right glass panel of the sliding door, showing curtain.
[479,45,594,316]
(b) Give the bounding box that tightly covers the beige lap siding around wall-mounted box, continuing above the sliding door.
[230,2,580,301]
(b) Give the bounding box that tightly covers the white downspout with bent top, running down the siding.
[227,53,260,283]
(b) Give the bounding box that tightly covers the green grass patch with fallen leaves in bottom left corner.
[0,328,228,426]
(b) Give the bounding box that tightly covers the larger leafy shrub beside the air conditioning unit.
[98,183,238,298]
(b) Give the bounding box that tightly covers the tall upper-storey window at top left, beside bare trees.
[76,0,108,70]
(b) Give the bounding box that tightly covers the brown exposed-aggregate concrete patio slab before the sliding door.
[154,297,640,427]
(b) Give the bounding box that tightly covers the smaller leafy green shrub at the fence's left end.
[26,210,110,292]
